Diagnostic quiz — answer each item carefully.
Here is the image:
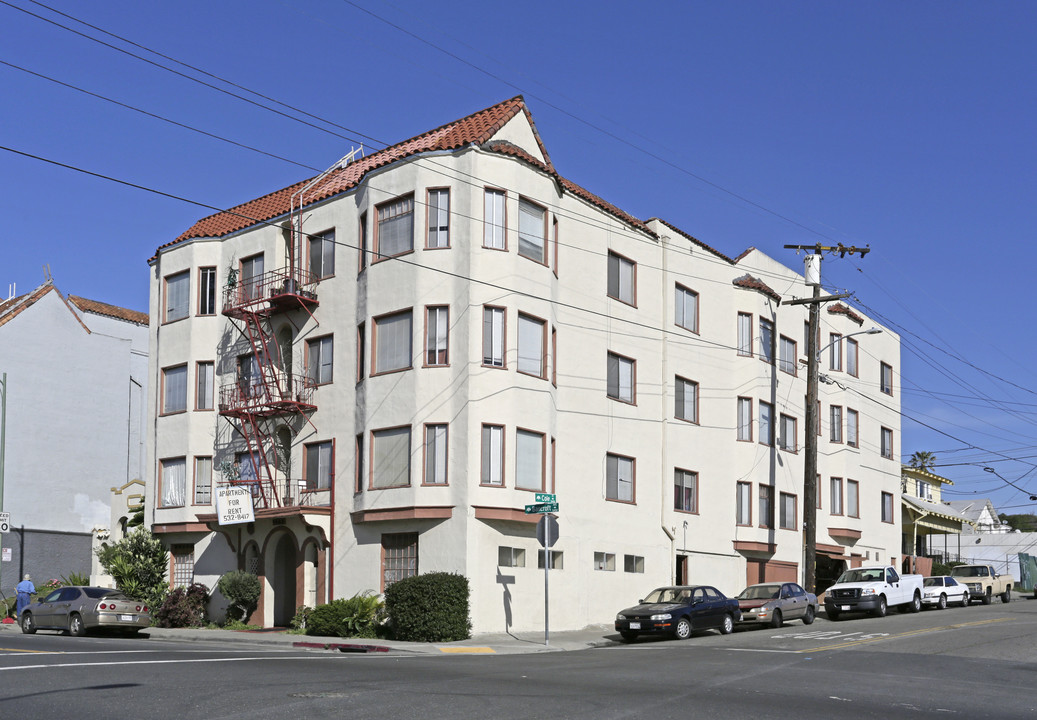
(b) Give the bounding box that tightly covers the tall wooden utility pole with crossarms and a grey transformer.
[785,243,870,592]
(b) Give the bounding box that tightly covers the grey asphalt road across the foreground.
[0,599,1037,720]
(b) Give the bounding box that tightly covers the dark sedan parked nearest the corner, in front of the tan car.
[616,585,741,640]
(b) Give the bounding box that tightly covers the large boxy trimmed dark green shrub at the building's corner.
[386,573,472,642]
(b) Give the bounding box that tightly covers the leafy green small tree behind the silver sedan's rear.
[96,527,169,608]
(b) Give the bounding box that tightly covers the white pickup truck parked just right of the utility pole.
[824,565,923,620]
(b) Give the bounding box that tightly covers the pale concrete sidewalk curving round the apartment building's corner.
[0,624,619,655]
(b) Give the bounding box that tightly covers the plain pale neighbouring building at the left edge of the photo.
[0,281,148,592]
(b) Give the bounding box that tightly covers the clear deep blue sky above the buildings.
[0,0,1037,513]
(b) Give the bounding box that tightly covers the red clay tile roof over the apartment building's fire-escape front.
[152,95,650,259]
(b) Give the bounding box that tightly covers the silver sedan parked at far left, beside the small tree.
[20,585,151,635]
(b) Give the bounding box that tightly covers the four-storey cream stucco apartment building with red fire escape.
[146,96,900,632]
